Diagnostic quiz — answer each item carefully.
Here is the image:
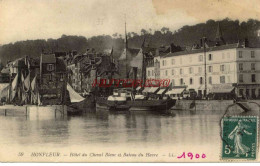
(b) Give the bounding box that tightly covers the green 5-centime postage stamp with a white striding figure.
[222,116,258,160]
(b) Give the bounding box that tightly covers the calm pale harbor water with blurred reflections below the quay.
[0,110,226,147]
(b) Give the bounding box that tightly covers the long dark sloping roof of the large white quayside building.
[162,43,240,58]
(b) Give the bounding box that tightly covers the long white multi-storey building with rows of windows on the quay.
[155,43,260,98]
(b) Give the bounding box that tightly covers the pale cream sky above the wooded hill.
[0,0,260,45]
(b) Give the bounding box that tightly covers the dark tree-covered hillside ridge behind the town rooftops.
[0,18,260,64]
